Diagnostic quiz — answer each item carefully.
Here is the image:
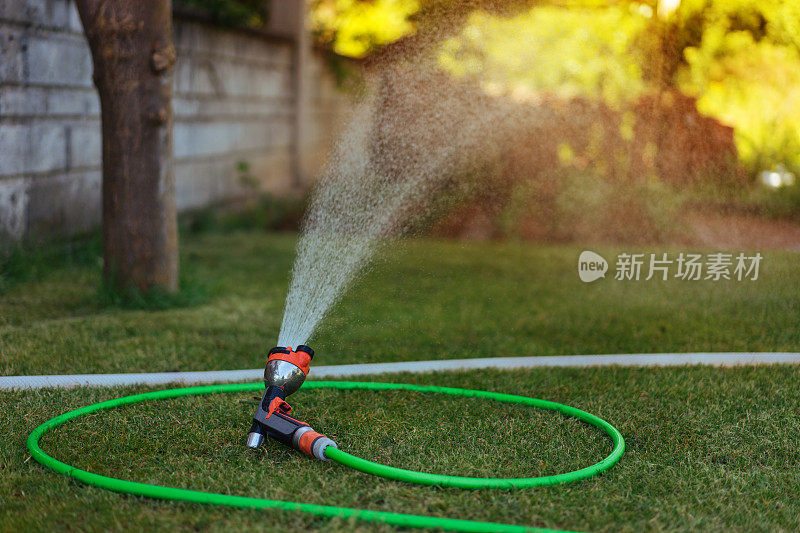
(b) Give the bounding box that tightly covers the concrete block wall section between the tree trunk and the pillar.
[173,20,294,210]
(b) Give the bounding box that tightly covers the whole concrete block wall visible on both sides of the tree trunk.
[0,0,349,242]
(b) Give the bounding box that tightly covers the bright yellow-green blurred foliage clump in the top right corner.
[673,0,800,177]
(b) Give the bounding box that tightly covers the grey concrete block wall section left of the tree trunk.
[0,0,101,241]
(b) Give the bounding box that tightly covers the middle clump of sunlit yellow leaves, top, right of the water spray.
[440,7,647,102]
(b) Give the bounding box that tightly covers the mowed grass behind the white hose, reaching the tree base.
[0,232,800,375]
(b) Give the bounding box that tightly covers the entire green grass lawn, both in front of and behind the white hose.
[0,233,800,531]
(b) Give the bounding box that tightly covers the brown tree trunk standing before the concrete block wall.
[77,0,178,291]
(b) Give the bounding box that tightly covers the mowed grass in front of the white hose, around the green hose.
[0,366,800,531]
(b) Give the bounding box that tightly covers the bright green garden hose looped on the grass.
[28,381,625,532]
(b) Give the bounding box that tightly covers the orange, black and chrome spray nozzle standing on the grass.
[247,344,337,461]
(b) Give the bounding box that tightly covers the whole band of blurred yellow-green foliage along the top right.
[312,0,800,191]
